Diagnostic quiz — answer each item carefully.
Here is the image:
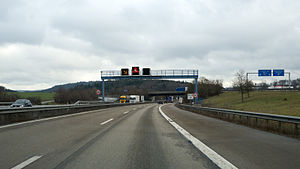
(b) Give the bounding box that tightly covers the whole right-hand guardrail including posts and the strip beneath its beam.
[178,104,300,139]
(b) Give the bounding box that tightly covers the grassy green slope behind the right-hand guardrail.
[203,91,300,116]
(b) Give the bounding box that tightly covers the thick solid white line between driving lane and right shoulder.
[159,106,237,169]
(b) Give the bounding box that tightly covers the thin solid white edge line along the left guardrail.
[0,109,107,129]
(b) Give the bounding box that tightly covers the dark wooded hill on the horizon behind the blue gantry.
[41,80,190,94]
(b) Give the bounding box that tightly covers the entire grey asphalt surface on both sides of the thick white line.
[0,104,300,169]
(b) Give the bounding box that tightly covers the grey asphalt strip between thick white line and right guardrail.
[162,105,300,169]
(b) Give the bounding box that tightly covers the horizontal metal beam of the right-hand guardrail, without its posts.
[180,104,300,124]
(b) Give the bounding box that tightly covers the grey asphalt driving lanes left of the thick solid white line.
[0,104,217,169]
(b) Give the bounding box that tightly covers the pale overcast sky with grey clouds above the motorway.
[0,0,300,90]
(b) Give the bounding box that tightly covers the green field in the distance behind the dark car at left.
[8,92,55,101]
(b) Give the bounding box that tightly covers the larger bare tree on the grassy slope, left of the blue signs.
[233,70,247,103]
